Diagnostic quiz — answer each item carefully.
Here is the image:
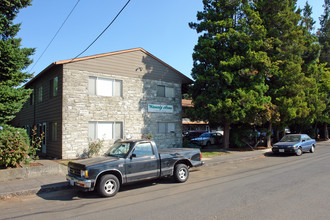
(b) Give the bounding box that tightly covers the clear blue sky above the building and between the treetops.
[14,0,324,78]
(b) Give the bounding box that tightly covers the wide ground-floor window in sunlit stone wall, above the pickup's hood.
[88,121,123,140]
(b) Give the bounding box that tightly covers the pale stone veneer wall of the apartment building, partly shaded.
[62,69,182,159]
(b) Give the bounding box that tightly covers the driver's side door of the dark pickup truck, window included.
[125,142,160,182]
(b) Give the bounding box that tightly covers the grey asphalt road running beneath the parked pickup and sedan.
[0,144,330,220]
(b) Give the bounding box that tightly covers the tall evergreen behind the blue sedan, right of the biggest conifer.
[256,0,310,139]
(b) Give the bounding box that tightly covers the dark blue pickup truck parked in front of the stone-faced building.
[66,140,204,197]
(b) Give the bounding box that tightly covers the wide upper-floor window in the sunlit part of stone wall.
[88,76,123,97]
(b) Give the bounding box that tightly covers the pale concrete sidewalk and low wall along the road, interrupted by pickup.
[0,149,271,199]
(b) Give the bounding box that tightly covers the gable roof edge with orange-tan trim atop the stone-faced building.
[26,48,193,85]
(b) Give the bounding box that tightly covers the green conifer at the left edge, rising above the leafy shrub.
[0,0,34,123]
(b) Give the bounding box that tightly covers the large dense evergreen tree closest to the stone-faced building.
[190,0,272,148]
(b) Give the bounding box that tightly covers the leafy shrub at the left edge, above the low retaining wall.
[0,125,42,168]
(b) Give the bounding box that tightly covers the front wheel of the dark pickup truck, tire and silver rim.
[97,174,120,197]
